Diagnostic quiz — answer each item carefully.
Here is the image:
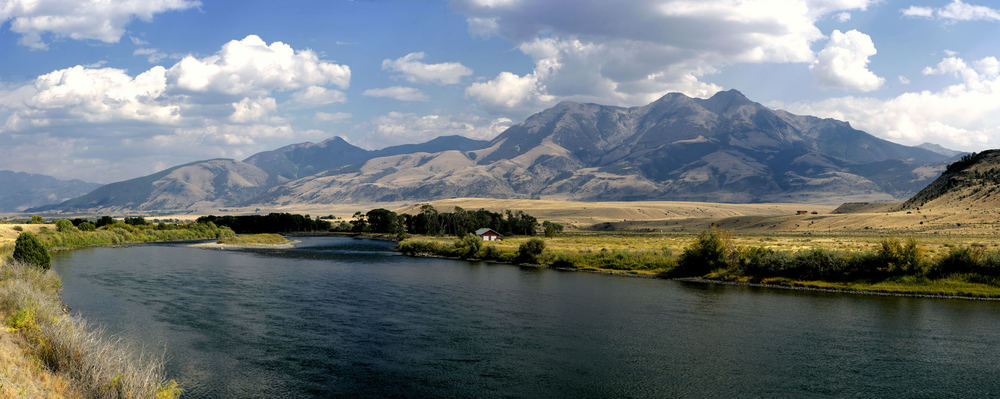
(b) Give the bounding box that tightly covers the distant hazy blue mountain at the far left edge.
[0,170,101,212]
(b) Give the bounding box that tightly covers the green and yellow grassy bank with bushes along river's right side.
[397,234,1000,299]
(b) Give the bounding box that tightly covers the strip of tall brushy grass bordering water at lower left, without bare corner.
[0,262,181,399]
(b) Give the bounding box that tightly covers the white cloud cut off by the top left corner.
[0,0,201,50]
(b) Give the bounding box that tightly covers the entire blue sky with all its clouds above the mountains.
[0,0,1000,183]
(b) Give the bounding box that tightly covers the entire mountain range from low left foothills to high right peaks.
[36,90,956,211]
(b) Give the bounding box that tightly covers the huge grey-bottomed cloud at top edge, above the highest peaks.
[452,0,874,112]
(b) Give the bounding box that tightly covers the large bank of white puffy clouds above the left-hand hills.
[0,36,350,182]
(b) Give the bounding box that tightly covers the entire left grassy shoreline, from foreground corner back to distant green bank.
[0,223,235,399]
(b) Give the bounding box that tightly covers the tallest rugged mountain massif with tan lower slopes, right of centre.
[258,90,948,204]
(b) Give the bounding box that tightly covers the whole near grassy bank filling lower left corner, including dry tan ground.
[0,261,181,399]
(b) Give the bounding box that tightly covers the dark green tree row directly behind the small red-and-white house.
[334,205,562,237]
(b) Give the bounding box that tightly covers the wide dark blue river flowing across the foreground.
[53,237,1000,398]
